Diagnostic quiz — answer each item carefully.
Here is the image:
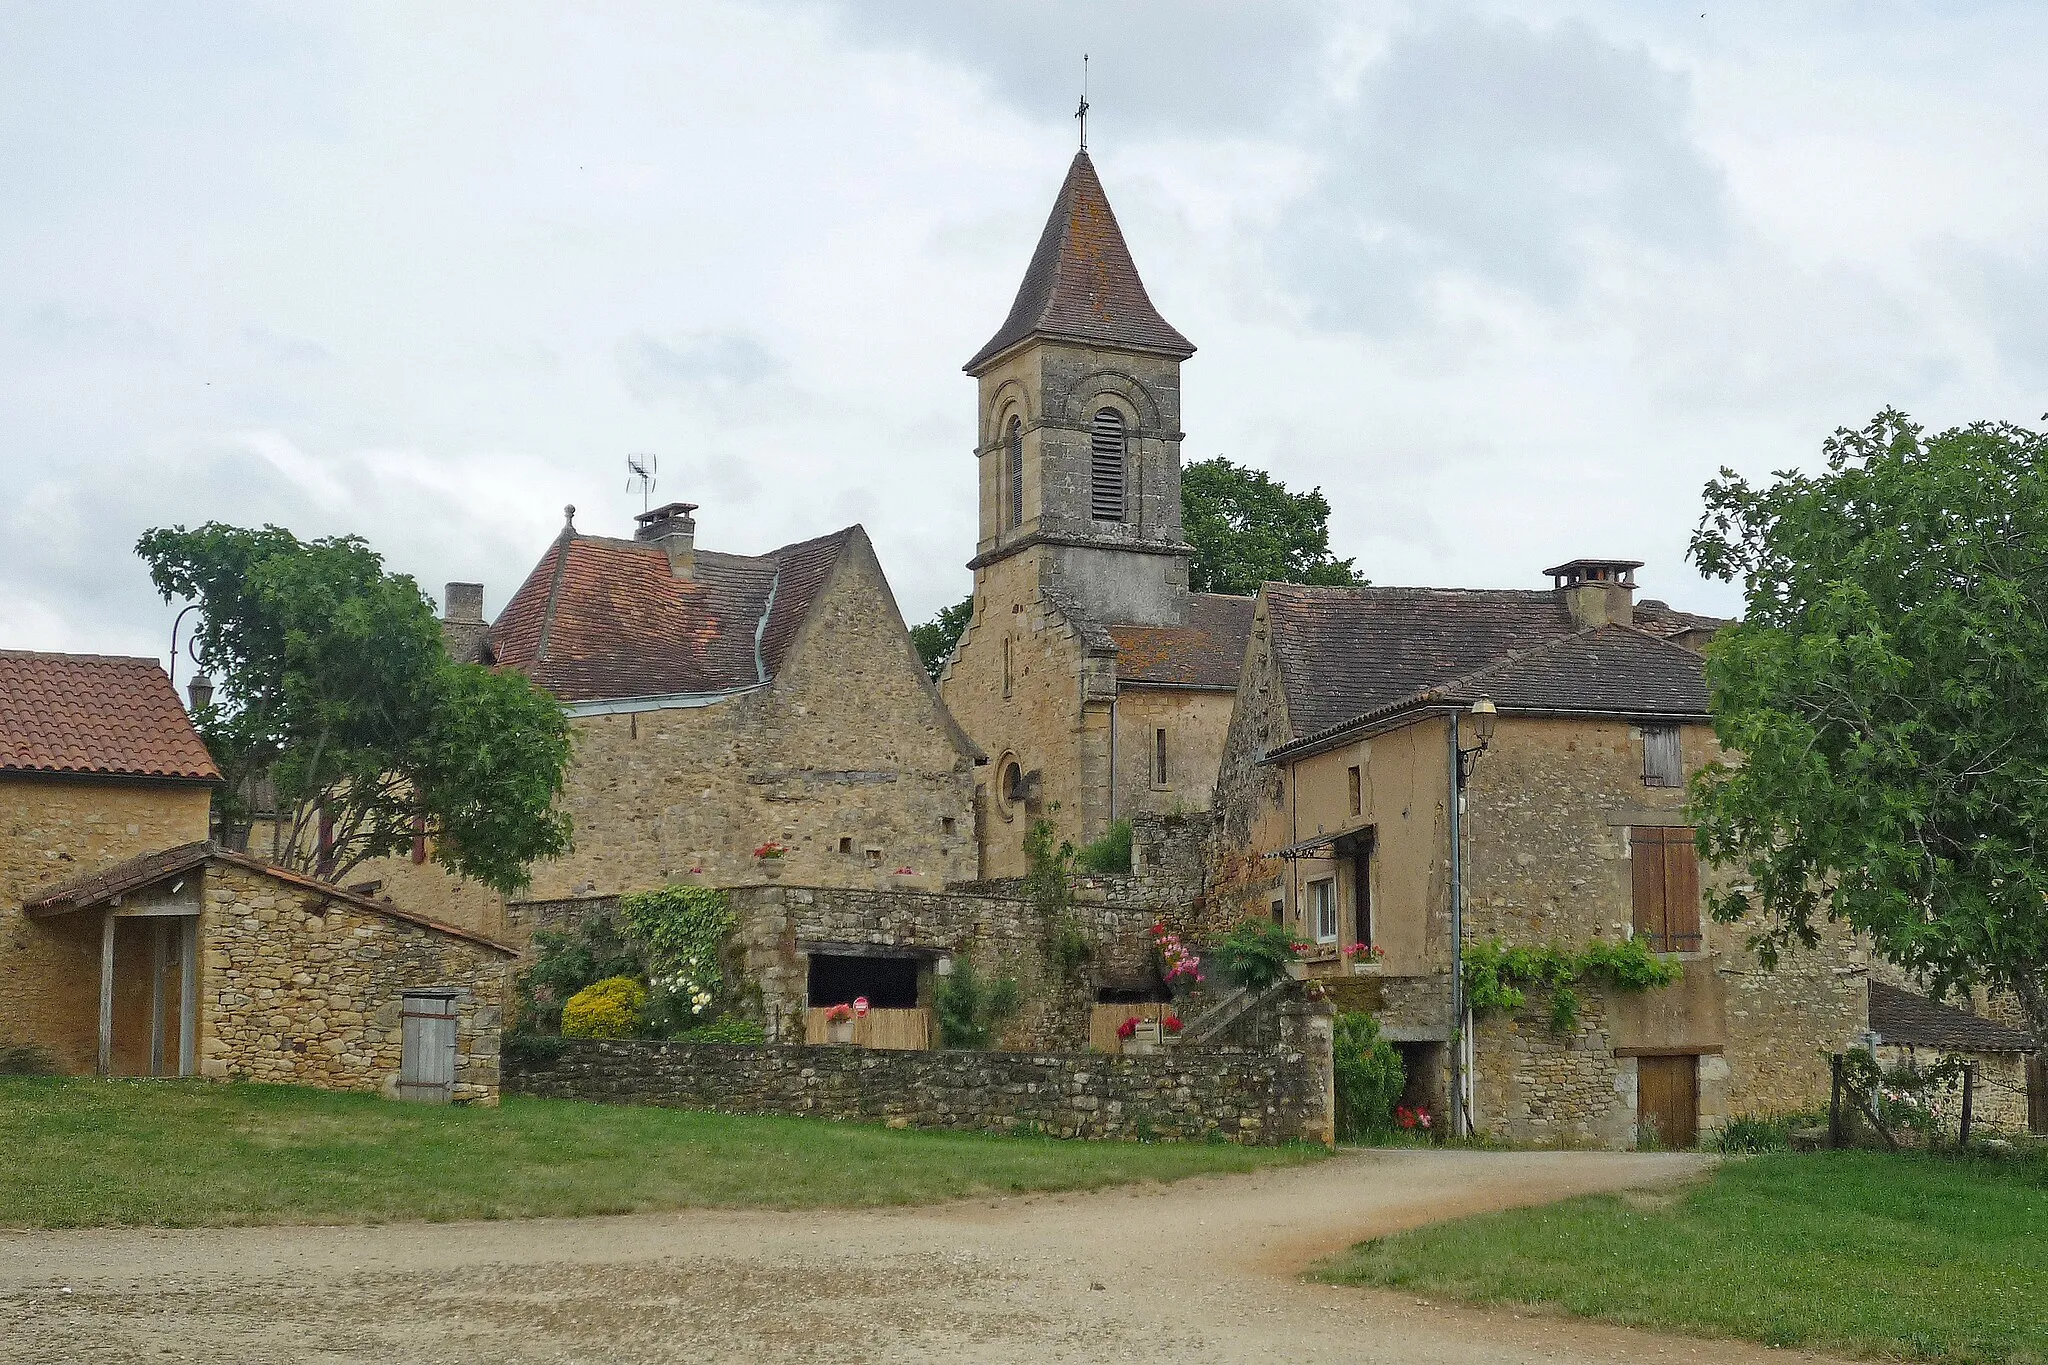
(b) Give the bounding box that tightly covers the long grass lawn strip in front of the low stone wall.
[0,1076,1319,1228]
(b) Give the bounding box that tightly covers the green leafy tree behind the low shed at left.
[135,522,569,892]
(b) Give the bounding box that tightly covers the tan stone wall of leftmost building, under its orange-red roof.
[0,776,213,1074]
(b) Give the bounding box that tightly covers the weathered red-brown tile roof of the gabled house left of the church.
[485,526,862,702]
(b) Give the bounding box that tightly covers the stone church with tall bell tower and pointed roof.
[940,151,1249,876]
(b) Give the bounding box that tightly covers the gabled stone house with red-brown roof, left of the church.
[358,503,981,937]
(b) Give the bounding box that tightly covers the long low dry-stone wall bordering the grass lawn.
[506,1011,1335,1144]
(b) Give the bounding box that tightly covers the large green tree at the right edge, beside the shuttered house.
[1692,409,2048,1056]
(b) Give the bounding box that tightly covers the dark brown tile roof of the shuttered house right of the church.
[1266,583,1718,745]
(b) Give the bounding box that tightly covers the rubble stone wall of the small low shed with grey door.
[199,862,510,1103]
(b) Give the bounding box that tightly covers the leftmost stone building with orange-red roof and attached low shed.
[0,651,514,1103]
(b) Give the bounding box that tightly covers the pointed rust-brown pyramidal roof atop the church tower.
[965,151,1194,375]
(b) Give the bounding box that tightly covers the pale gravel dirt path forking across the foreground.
[0,1152,1851,1365]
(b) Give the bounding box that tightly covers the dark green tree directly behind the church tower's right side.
[1180,454,1366,596]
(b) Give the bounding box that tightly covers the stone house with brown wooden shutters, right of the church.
[1212,559,2048,1146]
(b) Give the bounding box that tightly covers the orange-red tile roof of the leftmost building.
[0,649,221,782]
